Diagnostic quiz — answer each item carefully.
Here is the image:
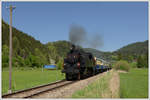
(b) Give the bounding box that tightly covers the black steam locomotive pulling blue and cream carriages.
[62,44,111,80]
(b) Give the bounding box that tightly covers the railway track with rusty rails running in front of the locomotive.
[2,80,76,98]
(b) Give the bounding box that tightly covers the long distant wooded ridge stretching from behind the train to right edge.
[84,40,148,61]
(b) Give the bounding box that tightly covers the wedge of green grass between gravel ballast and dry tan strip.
[72,72,111,98]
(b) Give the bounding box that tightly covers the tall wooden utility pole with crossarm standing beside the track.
[8,5,16,93]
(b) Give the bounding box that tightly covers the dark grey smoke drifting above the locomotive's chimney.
[69,25,103,49]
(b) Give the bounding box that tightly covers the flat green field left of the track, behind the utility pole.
[2,69,65,94]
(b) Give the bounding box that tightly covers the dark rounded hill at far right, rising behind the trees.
[114,40,148,55]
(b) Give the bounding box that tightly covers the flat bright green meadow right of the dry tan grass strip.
[120,69,148,98]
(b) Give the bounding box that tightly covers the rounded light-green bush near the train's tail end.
[114,60,130,71]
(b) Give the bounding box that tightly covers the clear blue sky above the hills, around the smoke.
[2,2,148,51]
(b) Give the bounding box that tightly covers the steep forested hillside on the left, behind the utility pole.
[2,20,69,67]
